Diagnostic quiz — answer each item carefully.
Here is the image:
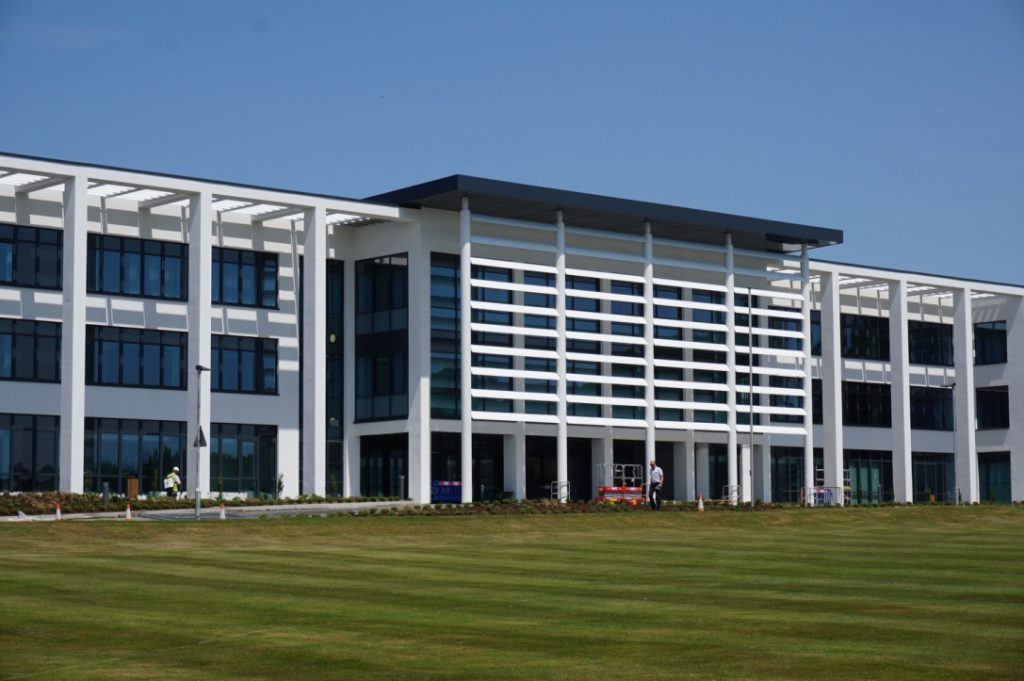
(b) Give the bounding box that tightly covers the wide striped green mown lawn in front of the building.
[0,506,1024,680]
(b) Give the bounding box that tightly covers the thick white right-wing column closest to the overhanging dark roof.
[819,272,843,499]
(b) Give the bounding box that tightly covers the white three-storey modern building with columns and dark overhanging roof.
[0,155,1024,504]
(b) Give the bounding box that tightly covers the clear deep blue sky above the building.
[0,0,1024,284]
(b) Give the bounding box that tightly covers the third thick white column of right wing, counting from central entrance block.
[953,289,978,504]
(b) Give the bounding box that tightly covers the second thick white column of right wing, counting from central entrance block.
[889,281,913,504]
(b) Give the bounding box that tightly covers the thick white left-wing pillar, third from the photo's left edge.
[299,206,327,496]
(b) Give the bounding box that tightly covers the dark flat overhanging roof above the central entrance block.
[364,175,843,252]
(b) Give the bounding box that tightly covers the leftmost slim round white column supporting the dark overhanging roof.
[459,197,473,504]
